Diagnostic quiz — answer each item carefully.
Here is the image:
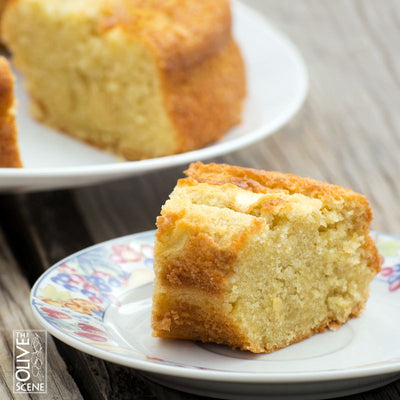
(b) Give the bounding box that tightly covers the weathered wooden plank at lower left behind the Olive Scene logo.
[0,219,82,400]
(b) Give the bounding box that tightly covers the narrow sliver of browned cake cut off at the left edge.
[0,56,22,168]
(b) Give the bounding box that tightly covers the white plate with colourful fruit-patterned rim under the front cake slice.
[31,232,400,400]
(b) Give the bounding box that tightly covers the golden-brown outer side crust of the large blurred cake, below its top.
[162,38,246,152]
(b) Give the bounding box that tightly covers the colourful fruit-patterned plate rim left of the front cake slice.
[31,232,154,354]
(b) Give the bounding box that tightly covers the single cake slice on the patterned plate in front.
[152,163,380,353]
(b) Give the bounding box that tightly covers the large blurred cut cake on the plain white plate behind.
[2,0,245,160]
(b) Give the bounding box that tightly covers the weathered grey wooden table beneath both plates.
[0,0,400,400]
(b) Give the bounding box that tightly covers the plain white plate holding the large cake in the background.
[0,1,307,192]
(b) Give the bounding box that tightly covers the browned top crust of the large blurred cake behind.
[4,0,231,70]
